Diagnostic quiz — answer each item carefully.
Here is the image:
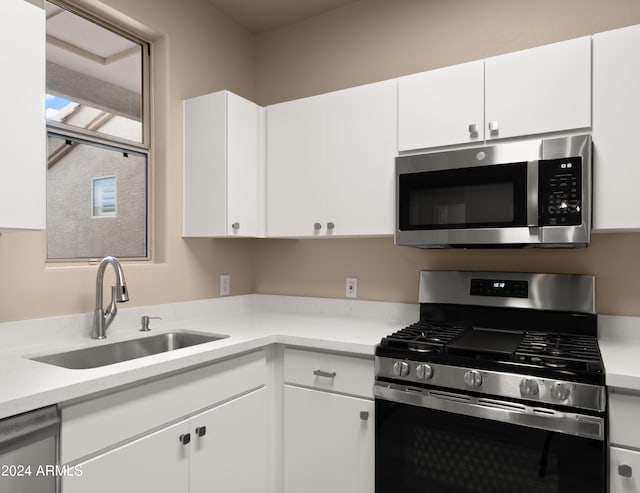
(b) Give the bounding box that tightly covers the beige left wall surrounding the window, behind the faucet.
[0,0,255,321]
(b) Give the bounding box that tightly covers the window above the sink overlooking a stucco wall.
[45,0,150,260]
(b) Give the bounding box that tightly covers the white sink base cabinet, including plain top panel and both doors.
[60,351,273,493]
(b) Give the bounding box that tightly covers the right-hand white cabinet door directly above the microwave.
[485,36,591,140]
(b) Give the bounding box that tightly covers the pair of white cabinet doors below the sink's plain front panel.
[63,388,269,493]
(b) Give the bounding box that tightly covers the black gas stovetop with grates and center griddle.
[376,320,604,385]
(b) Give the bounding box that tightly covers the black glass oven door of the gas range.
[375,384,606,493]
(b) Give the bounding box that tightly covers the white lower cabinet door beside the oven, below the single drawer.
[284,385,375,493]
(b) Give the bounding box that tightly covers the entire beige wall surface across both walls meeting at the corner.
[0,0,640,321]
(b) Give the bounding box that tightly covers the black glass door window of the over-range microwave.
[399,163,527,230]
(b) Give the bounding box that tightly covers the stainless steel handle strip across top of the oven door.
[373,382,605,440]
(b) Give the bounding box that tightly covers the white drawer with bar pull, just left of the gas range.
[284,348,374,399]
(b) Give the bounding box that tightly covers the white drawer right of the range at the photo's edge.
[609,392,640,448]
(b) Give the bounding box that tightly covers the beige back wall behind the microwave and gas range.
[255,0,640,315]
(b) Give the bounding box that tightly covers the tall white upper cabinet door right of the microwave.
[593,26,640,232]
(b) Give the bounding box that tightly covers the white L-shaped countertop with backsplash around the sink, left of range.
[0,295,418,418]
